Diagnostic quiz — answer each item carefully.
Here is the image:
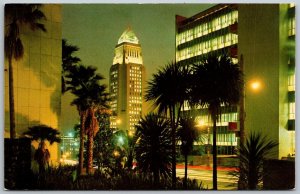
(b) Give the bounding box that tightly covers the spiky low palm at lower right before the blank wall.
[237,132,278,190]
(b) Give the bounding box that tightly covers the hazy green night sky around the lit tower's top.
[62,4,213,133]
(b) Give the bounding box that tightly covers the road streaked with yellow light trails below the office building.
[176,165,237,190]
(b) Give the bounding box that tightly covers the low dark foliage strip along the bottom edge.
[35,166,204,190]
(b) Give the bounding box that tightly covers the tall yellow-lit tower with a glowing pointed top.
[109,28,145,133]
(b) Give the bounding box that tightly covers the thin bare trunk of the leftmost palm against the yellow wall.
[8,56,16,139]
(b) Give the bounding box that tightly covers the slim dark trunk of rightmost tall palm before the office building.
[212,113,218,190]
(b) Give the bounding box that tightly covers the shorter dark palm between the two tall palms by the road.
[177,117,199,189]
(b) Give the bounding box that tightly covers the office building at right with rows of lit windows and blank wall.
[176,4,295,158]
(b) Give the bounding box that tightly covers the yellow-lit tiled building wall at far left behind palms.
[5,4,62,164]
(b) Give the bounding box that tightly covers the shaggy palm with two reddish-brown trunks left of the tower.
[66,65,109,174]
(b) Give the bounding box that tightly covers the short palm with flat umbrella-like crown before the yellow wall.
[23,125,60,173]
